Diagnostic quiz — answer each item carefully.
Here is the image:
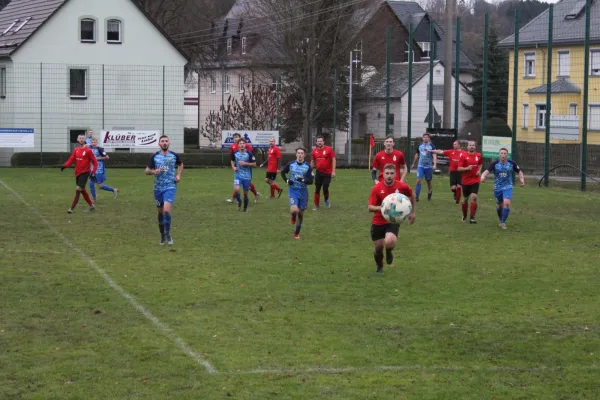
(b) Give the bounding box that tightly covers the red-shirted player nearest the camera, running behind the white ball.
[369,164,415,273]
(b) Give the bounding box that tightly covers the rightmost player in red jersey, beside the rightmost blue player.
[458,140,483,224]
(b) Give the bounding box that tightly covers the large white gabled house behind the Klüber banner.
[0,0,187,165]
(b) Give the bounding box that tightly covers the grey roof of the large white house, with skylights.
[0,0,189,60]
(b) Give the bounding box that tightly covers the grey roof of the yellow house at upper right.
[499,0,600,48]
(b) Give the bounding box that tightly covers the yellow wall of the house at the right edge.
[507,45,600,144]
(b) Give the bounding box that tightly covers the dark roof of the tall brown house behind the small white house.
[387,0,476,69]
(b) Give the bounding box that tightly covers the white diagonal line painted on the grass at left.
[0,179,217,374]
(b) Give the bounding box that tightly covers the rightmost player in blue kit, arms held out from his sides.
[481,148,525,229]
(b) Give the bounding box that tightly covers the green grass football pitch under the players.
[0,169,600,399]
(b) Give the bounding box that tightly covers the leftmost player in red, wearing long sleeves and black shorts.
[60,135,98,214]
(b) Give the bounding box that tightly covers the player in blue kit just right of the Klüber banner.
[146,135,183,246]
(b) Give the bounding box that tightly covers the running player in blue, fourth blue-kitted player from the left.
[281,147,314,239]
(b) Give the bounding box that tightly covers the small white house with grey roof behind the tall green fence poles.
[352,61,473,138]
